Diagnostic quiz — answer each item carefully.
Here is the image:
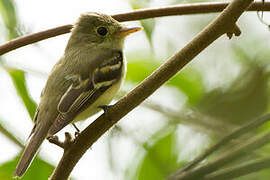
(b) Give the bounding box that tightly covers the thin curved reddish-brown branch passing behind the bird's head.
[0,2,270,55]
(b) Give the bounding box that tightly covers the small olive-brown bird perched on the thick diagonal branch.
[14,12,142,178]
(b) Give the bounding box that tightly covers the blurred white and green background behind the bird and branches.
[0,0,270,180]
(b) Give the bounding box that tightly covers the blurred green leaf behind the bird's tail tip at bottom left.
[0,153,54,180]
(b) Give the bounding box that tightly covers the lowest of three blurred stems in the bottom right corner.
[201,158,270,180]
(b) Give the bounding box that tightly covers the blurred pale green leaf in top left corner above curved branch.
[0,0,19,40]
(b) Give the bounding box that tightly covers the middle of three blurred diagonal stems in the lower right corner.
[169,132,270,180]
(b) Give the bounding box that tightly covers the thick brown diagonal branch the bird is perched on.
[51,0,252,180]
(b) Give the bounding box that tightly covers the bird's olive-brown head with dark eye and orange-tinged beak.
[69,12,141,49]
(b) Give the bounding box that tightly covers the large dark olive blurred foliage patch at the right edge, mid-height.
[196,46,269,124]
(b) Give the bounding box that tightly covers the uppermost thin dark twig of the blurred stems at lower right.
[173,113,270,174]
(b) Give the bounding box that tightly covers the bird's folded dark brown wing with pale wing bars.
[49,51,123,135]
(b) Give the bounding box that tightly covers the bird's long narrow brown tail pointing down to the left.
[14,123,49,177]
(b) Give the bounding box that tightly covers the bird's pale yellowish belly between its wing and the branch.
[74,61,126,121]
